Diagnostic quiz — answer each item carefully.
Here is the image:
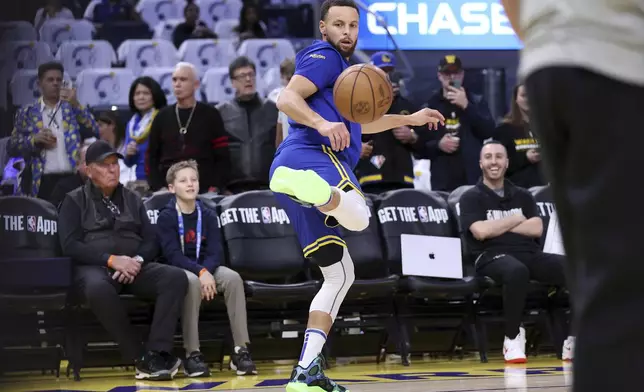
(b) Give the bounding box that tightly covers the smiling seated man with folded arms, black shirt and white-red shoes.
[460,140,574,363]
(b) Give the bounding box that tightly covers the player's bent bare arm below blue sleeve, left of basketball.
[277,75,326,129]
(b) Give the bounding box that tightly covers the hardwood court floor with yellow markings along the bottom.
[0,356,571,392]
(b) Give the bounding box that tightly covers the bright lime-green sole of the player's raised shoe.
[270,166,331,206]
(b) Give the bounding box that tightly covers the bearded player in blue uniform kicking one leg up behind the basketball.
[270,0,444,392]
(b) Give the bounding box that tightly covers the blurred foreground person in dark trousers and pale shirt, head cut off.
[503,0,644,392]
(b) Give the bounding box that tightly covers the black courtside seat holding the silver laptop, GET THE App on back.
[378,189,477,298]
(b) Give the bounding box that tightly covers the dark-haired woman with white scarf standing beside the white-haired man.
[123,76,168,181]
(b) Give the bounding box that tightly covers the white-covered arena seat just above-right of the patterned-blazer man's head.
[56,41,117,79]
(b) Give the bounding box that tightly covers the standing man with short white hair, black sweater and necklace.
[146,63,230,192]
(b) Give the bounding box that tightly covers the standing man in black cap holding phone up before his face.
[415,54,495,192]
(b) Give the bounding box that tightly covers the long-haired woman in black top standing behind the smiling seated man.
[496,84,545,188]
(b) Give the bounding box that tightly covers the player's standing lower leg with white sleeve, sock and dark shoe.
[286,244,355,392]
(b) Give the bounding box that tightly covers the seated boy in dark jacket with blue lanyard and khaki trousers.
[157,160,257,377]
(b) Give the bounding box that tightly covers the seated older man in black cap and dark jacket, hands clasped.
[58,140,188,380]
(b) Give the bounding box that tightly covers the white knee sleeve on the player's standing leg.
[309,245,355,321]
